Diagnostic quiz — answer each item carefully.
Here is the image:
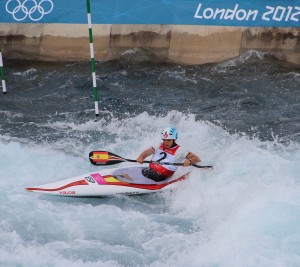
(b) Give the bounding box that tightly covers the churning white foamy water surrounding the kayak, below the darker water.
[0,111,300,267]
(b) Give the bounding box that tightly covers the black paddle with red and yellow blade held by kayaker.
[89,151,212,168]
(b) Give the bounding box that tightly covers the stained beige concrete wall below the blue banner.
[0,24,300,65]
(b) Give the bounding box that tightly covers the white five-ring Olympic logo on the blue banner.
[5,0,54,21]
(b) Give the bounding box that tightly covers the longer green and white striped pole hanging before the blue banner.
[86,0,99,116]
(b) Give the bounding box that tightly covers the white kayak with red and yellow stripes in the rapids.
[26,166,190,197]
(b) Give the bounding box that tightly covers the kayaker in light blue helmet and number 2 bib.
[136,127,201,182]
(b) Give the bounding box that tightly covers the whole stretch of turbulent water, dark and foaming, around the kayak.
[0,50,300,267]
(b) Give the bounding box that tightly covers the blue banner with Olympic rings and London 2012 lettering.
[0,0,300,27]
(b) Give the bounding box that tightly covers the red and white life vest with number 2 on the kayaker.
[149,143,180,177]
